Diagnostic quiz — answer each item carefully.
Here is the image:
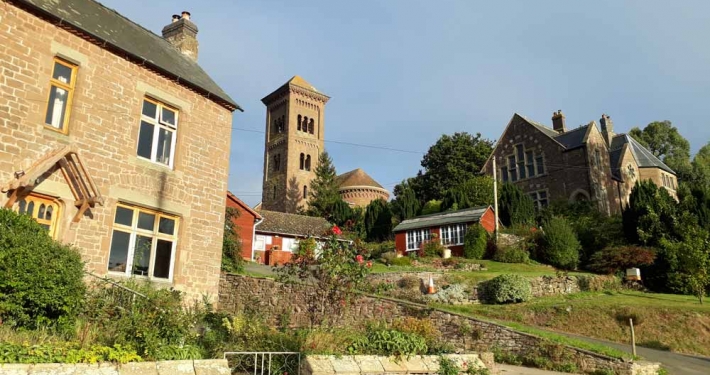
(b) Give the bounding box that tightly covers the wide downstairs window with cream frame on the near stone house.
[108,204,178,281]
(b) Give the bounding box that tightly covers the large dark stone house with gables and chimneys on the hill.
[483,111,677,214]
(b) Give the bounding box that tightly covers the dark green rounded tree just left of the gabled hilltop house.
[412,132,493,202]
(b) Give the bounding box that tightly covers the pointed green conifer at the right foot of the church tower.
[306,151,341,221]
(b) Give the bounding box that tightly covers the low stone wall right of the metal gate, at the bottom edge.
[301,353,495,375]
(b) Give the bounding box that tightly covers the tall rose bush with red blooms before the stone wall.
[276,231,372,327]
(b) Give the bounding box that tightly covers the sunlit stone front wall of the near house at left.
[0,2,232,298]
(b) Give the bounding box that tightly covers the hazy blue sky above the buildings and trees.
[102,0,710,204]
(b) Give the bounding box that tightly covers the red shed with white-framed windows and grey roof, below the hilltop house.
[393,206,496,256]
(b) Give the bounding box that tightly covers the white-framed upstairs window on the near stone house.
[138,98,178,168]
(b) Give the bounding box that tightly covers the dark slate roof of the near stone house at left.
[16,0,242,111]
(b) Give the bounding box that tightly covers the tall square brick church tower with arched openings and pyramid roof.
[261,76,330,213]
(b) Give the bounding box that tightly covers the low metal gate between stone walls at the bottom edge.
[224,352,301,375]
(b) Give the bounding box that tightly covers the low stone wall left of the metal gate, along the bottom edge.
[0,359,232,375]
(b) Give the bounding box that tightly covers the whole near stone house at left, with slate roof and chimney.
[0,0,240,297]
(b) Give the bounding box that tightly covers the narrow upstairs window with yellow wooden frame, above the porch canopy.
[44,57,77,134]
